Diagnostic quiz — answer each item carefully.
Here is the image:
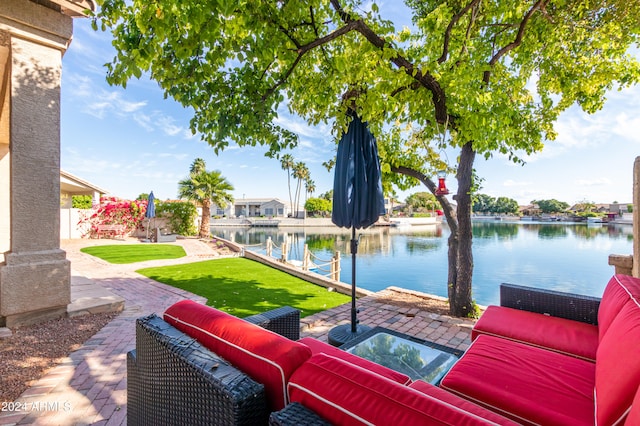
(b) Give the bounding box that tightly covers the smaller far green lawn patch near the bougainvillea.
[80,244,187,264]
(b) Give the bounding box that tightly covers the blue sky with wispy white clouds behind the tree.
[61,12,640,204]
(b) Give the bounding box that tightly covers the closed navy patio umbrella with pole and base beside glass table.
[329,114,385,346]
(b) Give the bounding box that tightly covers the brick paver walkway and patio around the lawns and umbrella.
[0,239,473,426]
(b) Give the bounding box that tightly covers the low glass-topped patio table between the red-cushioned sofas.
[340,327,462,385]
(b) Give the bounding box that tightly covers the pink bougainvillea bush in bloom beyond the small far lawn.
[78,197,147,236]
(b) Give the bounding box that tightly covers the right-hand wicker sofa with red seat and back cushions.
[440,275,640,425]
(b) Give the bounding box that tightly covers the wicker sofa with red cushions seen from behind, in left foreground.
[127,300,515,426]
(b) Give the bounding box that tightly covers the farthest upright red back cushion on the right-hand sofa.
[598,275,640,340]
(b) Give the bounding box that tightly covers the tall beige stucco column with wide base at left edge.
[0,0,73,327]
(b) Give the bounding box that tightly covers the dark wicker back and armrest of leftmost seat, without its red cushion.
[127,307,300,425]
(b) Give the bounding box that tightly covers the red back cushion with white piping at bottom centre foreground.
[288,354,520,425]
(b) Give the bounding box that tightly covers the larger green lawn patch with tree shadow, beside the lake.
[137,258,351,318]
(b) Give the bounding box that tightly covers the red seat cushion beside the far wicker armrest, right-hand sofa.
[471,306,598,361]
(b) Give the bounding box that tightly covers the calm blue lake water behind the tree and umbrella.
[212,221,633,305]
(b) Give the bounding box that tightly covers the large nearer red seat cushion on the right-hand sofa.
[440,335,596,425]
